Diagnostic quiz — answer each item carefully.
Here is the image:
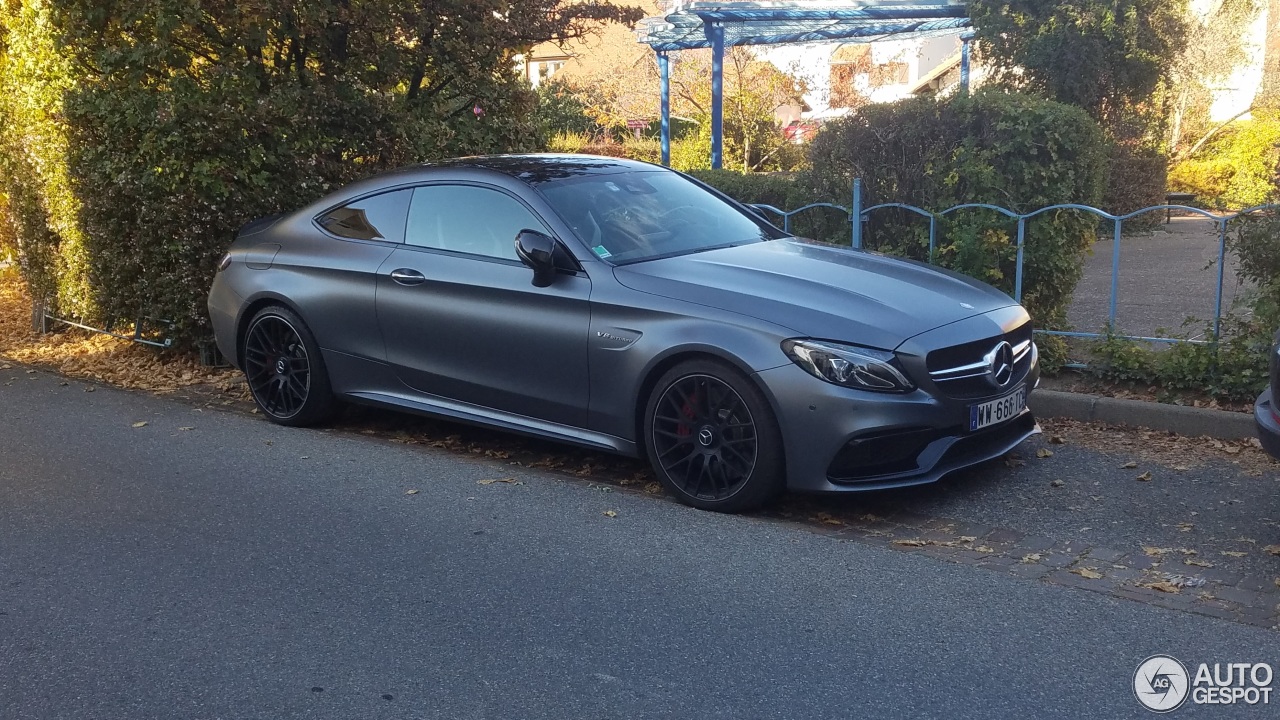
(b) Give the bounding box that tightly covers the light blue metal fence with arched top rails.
[755,178,1280,343]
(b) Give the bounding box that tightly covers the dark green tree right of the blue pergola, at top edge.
[969,0,1187,126]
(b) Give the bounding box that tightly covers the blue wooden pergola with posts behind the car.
[637,0,972,168]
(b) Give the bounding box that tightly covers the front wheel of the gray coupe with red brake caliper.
[644,360,786,512]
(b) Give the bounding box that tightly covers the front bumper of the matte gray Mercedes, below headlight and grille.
[758,356,1039,492]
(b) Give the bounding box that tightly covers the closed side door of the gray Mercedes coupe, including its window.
[376,183,591,428]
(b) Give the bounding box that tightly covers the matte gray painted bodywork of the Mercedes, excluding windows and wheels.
[209,158,1038,491]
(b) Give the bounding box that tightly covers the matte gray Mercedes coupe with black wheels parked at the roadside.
[209,155,1039,511]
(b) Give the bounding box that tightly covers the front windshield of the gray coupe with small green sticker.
[538,170,772,263]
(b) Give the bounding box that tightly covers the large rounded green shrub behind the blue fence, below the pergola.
[801,91,1107,364]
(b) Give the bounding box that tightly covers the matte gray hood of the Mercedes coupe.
[614,240,1016,348]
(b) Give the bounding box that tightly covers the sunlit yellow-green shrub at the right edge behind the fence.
[1169,110,1280,209]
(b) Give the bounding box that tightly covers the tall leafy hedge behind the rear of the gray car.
[0,0,641,345]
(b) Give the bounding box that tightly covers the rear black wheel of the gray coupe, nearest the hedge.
[241,305,334,428]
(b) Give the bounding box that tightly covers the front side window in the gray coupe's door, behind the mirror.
[404,184,549,260]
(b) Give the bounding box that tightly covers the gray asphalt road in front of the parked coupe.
[0,373,1280,720]
